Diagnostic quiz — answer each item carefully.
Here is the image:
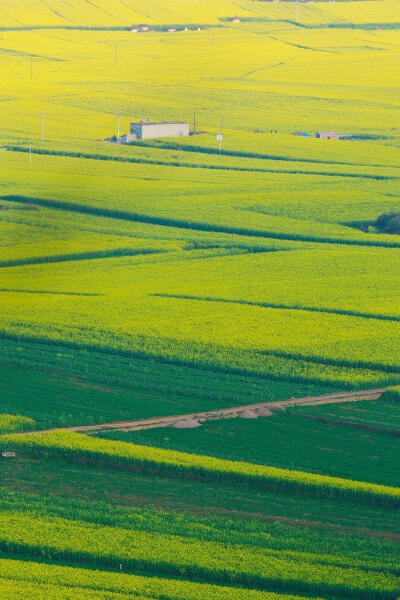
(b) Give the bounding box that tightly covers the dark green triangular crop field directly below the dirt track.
[99,401,400,486]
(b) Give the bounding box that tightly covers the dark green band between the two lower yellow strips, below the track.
[2,456,400,536]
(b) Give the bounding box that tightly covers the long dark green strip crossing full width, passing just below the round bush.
[4,194,400,248]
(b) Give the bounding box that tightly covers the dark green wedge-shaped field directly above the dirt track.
[0,350,333,431]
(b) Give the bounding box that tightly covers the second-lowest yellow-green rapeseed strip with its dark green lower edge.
[0,504,398,600]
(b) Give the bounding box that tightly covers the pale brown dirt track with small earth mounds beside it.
[16,388,388,435]
